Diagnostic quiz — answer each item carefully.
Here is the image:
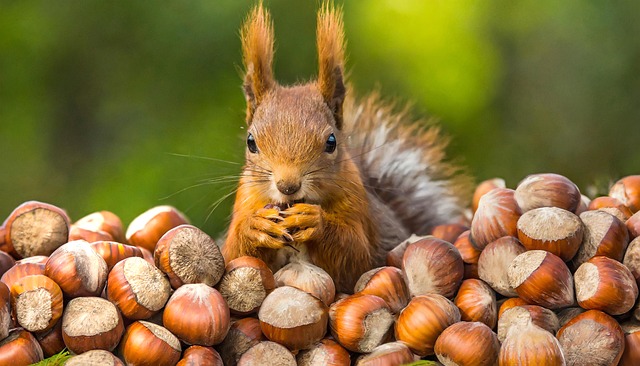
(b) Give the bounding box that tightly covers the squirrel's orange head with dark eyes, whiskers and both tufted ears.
[241,3,348,204]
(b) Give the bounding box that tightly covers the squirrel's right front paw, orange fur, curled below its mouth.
[280,203,324,242]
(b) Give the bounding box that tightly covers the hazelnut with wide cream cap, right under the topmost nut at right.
[518,207,583,262]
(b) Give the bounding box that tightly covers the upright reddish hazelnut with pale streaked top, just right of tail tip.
[471,188,522,250]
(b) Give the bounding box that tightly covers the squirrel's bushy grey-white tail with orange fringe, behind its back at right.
[344,92,472,235]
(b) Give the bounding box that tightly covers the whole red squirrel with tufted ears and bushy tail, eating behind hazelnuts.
[223,3,469,293]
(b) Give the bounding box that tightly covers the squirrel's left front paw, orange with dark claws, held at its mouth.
[248,207,294,249]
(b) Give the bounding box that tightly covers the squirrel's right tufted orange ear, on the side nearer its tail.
[316,1,346,129]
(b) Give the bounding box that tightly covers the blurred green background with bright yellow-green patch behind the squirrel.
[0,0,640,234]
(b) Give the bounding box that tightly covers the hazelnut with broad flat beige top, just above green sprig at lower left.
[62,297,124,354]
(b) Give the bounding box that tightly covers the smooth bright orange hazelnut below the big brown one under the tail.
[395,294,460,356]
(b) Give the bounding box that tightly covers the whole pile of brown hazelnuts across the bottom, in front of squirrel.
[0,174,640,365]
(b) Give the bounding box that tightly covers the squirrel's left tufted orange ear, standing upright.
[240,2,275,124]
